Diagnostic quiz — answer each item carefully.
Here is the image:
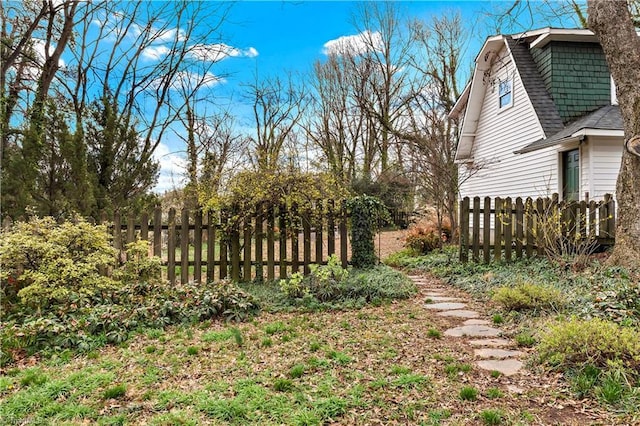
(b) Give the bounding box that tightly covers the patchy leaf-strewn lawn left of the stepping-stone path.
[0,278,616,425]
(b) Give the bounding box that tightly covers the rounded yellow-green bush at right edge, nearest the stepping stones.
[538,318,640,370]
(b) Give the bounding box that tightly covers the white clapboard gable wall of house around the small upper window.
[460,51,558,198]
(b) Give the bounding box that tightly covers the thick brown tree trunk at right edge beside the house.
[587,0,640,268]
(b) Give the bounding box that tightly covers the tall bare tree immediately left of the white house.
[401,14,468,233]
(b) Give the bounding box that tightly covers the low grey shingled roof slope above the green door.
[514,105,624,154]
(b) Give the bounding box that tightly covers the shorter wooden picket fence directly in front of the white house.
[460,194,615,263]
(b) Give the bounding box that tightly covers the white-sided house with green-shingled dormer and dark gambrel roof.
[450,28,624,201]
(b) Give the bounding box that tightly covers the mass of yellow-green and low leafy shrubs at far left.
[0,223,258,364]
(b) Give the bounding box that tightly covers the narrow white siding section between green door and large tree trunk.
[589,137,623,199]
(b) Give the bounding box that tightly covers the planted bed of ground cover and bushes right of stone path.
[386,247,640,413]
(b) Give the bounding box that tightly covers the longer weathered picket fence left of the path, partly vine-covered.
[110,200,348,283]
